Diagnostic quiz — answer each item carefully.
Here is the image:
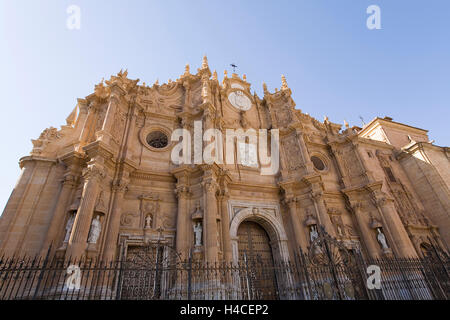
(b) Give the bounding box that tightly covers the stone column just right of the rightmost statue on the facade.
[375,196,417,258]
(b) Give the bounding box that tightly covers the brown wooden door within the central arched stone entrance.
[237,221,279,300]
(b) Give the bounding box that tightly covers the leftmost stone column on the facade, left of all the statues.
[40,168,77,257]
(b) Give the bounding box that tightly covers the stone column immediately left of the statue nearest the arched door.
[176,185,192,260]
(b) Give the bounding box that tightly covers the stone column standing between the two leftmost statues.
[66,161,105,259]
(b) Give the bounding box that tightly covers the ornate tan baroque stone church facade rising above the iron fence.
[0,57,450,262]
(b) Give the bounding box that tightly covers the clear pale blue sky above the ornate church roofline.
[0,0,450,212]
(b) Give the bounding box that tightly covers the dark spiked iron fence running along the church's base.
[0,251,450,300]
